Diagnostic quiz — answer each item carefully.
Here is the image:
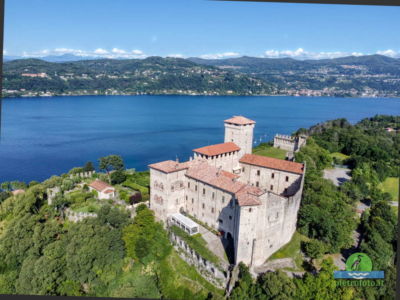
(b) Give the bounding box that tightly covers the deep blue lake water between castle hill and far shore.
[0,96,400,182]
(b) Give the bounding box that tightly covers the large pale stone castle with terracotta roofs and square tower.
[149,116,305,266]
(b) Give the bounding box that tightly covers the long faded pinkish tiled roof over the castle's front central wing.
[186,161,264,206]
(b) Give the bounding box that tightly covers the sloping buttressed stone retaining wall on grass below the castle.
[170,232,229,289]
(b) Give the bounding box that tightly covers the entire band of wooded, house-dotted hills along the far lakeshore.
[3,55,400,97]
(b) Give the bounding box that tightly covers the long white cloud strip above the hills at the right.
[263,48,400,59]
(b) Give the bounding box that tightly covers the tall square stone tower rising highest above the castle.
[224,116,256,158]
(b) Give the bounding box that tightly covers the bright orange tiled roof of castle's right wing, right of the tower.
[240,154,304,174]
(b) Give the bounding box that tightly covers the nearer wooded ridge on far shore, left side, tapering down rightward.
[3,56,276,97]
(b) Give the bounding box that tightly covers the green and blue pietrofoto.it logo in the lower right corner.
[333,252,384,280]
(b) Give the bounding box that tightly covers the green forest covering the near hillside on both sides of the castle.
[0,116,400,300]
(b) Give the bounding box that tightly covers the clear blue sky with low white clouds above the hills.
[3,0,400,59]
